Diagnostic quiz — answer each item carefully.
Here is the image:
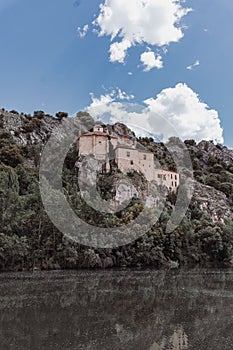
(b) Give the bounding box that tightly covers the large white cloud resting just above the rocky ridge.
[87,83,223,143]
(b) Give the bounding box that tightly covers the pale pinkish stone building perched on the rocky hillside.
[78,124,179,191]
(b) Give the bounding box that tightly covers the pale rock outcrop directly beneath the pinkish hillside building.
[75,156,159,212]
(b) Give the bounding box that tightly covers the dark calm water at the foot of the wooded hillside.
[0,269,233,350]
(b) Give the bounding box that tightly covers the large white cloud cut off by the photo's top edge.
[93,0,191,63]
